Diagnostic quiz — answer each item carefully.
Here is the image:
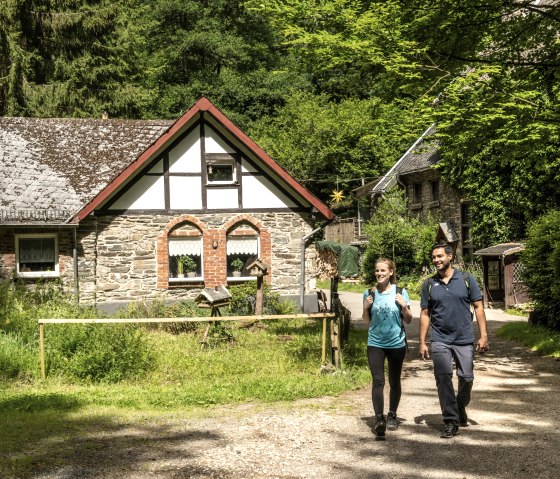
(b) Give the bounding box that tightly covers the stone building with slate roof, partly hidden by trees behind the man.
[370,125,474,261]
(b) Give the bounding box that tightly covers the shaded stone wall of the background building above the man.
[401,170,464,261]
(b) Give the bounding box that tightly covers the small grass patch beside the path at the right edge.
[497,322,560,358]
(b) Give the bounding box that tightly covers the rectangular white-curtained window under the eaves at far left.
[16,234,59,277]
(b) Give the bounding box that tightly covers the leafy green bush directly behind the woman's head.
[362,188,437,284]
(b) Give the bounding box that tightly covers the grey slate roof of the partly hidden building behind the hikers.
[371,124,440,195]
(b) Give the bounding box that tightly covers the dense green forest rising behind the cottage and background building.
[0,0,560,246]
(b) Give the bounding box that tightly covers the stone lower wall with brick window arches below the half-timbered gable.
[78,212,315,303]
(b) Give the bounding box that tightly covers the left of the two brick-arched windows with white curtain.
[169,236,203,282]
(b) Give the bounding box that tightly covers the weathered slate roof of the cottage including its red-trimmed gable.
[0,98,334,224]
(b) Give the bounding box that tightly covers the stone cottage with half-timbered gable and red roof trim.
[0,98,334,312]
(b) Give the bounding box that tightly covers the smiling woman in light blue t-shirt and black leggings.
[362,258,412,437]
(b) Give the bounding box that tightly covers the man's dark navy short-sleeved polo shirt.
[420,269,482,345]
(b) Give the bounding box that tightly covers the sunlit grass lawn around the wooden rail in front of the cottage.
[0,320,370,478]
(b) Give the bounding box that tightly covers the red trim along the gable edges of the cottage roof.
[70,97,335,223]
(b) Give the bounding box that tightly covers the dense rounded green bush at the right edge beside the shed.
[522,210,560,330]
